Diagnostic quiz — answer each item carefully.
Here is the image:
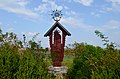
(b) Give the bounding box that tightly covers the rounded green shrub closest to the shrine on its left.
[17,50,48,79]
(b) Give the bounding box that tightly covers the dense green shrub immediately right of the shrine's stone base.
[68,43,103,79]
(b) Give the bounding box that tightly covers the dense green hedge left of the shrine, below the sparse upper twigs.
[0,46,52,79]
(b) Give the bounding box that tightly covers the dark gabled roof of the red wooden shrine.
[44,22,71,37]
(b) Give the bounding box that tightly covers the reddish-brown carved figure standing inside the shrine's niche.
[52,30,64,67]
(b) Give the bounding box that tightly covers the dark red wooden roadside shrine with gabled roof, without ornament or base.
[44,21,71,67]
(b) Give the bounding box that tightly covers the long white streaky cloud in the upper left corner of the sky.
[0,0,38,18]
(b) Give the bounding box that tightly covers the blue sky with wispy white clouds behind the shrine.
[0,0,120,47]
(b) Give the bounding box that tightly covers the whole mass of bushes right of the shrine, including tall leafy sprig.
[67,31,120,79]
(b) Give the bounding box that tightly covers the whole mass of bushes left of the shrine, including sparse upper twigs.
[0,30,53,79]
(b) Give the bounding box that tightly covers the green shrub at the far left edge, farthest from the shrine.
[0,45,20,79]
